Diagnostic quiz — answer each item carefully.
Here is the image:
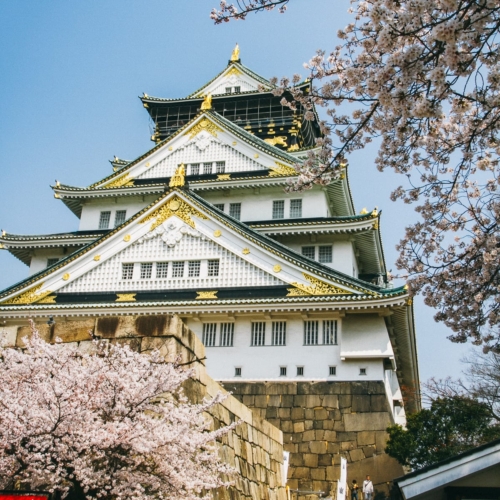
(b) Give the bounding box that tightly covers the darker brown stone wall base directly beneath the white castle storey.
[224,381,404,498]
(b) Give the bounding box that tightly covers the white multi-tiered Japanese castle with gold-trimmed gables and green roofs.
[0,48,419,426]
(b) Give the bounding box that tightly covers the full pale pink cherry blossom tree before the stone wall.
[0,324,232,500]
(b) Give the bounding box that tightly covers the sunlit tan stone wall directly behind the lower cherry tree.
[7,315,287,500]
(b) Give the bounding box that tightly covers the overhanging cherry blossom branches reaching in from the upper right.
[211,0,500,353]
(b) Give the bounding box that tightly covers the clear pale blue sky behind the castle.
[0,0,469,381]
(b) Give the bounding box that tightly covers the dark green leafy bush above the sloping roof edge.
[385,396,500,469]
